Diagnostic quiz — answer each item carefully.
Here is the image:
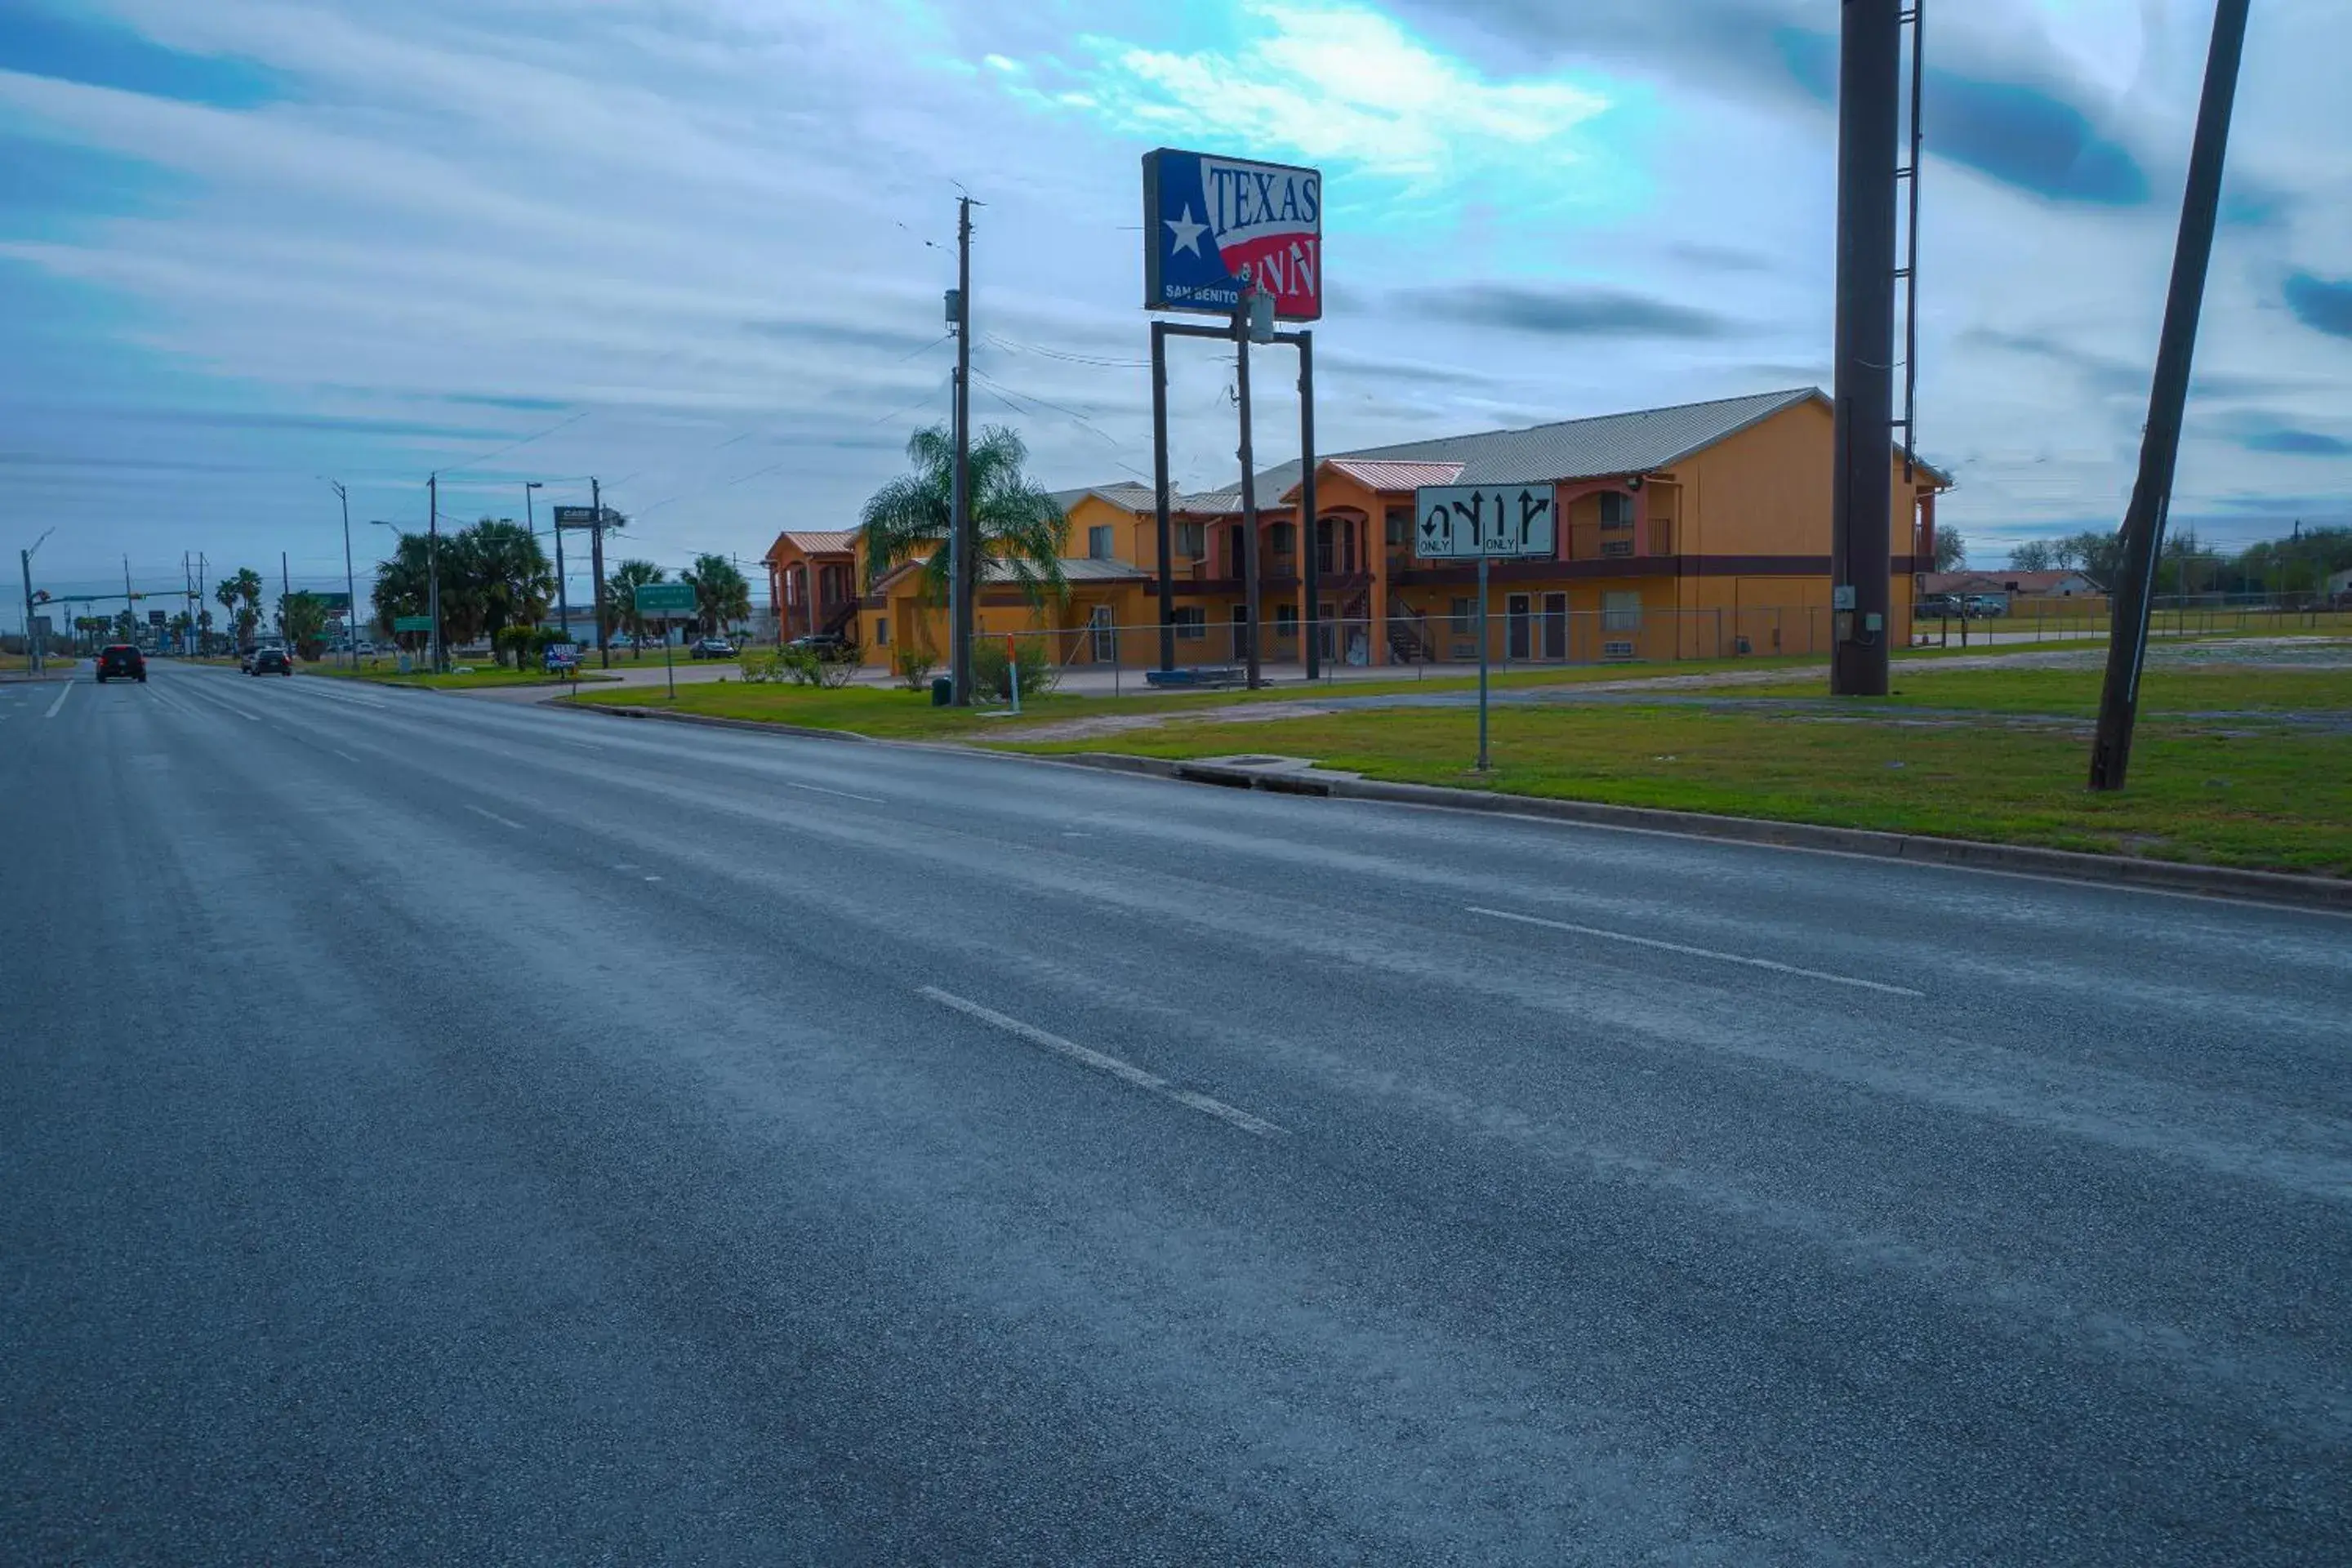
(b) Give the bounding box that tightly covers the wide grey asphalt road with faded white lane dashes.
[0,663,2352,1566]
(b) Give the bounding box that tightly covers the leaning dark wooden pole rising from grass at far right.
[2091,0,2248,790]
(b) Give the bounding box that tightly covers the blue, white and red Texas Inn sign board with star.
[1143,148,1322,322]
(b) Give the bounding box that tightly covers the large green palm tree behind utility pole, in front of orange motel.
[858,425,1070,604]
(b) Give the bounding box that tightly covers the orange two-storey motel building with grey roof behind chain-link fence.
[790,388,1950,666]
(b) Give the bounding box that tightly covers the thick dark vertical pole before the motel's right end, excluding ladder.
[1830,0,1903,696]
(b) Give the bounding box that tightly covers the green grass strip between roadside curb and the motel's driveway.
[1018,703,2352,877]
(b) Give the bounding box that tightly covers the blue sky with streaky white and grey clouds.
[0,0,2352,626]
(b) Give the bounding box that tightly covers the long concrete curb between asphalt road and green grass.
[559,703,2352,915]
